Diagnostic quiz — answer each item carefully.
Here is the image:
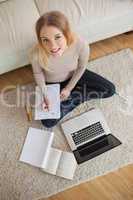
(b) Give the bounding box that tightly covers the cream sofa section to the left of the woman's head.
[0,0,39,74]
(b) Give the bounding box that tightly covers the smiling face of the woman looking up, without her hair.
[40,26,67,57]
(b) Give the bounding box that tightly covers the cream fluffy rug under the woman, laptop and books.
[0,49,133,200]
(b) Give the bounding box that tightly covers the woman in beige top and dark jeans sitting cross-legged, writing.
[30,11,115,127]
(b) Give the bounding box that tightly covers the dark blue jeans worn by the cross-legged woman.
[41,69,115,128]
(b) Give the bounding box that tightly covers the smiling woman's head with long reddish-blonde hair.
[33,11,76,69]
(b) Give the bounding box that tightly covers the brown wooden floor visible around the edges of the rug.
[0,32,133,200]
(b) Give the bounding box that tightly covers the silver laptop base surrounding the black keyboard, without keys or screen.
[61,108,110,150]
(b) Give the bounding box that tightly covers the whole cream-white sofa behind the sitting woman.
[0,0,133,74]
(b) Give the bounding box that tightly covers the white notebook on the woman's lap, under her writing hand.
[35,84,60,120]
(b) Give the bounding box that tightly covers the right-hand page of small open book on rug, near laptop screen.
[56,152,77,180]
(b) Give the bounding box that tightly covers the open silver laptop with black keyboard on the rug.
[61,108,121,164]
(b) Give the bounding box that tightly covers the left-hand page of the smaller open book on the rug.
[42,148,62,175]
